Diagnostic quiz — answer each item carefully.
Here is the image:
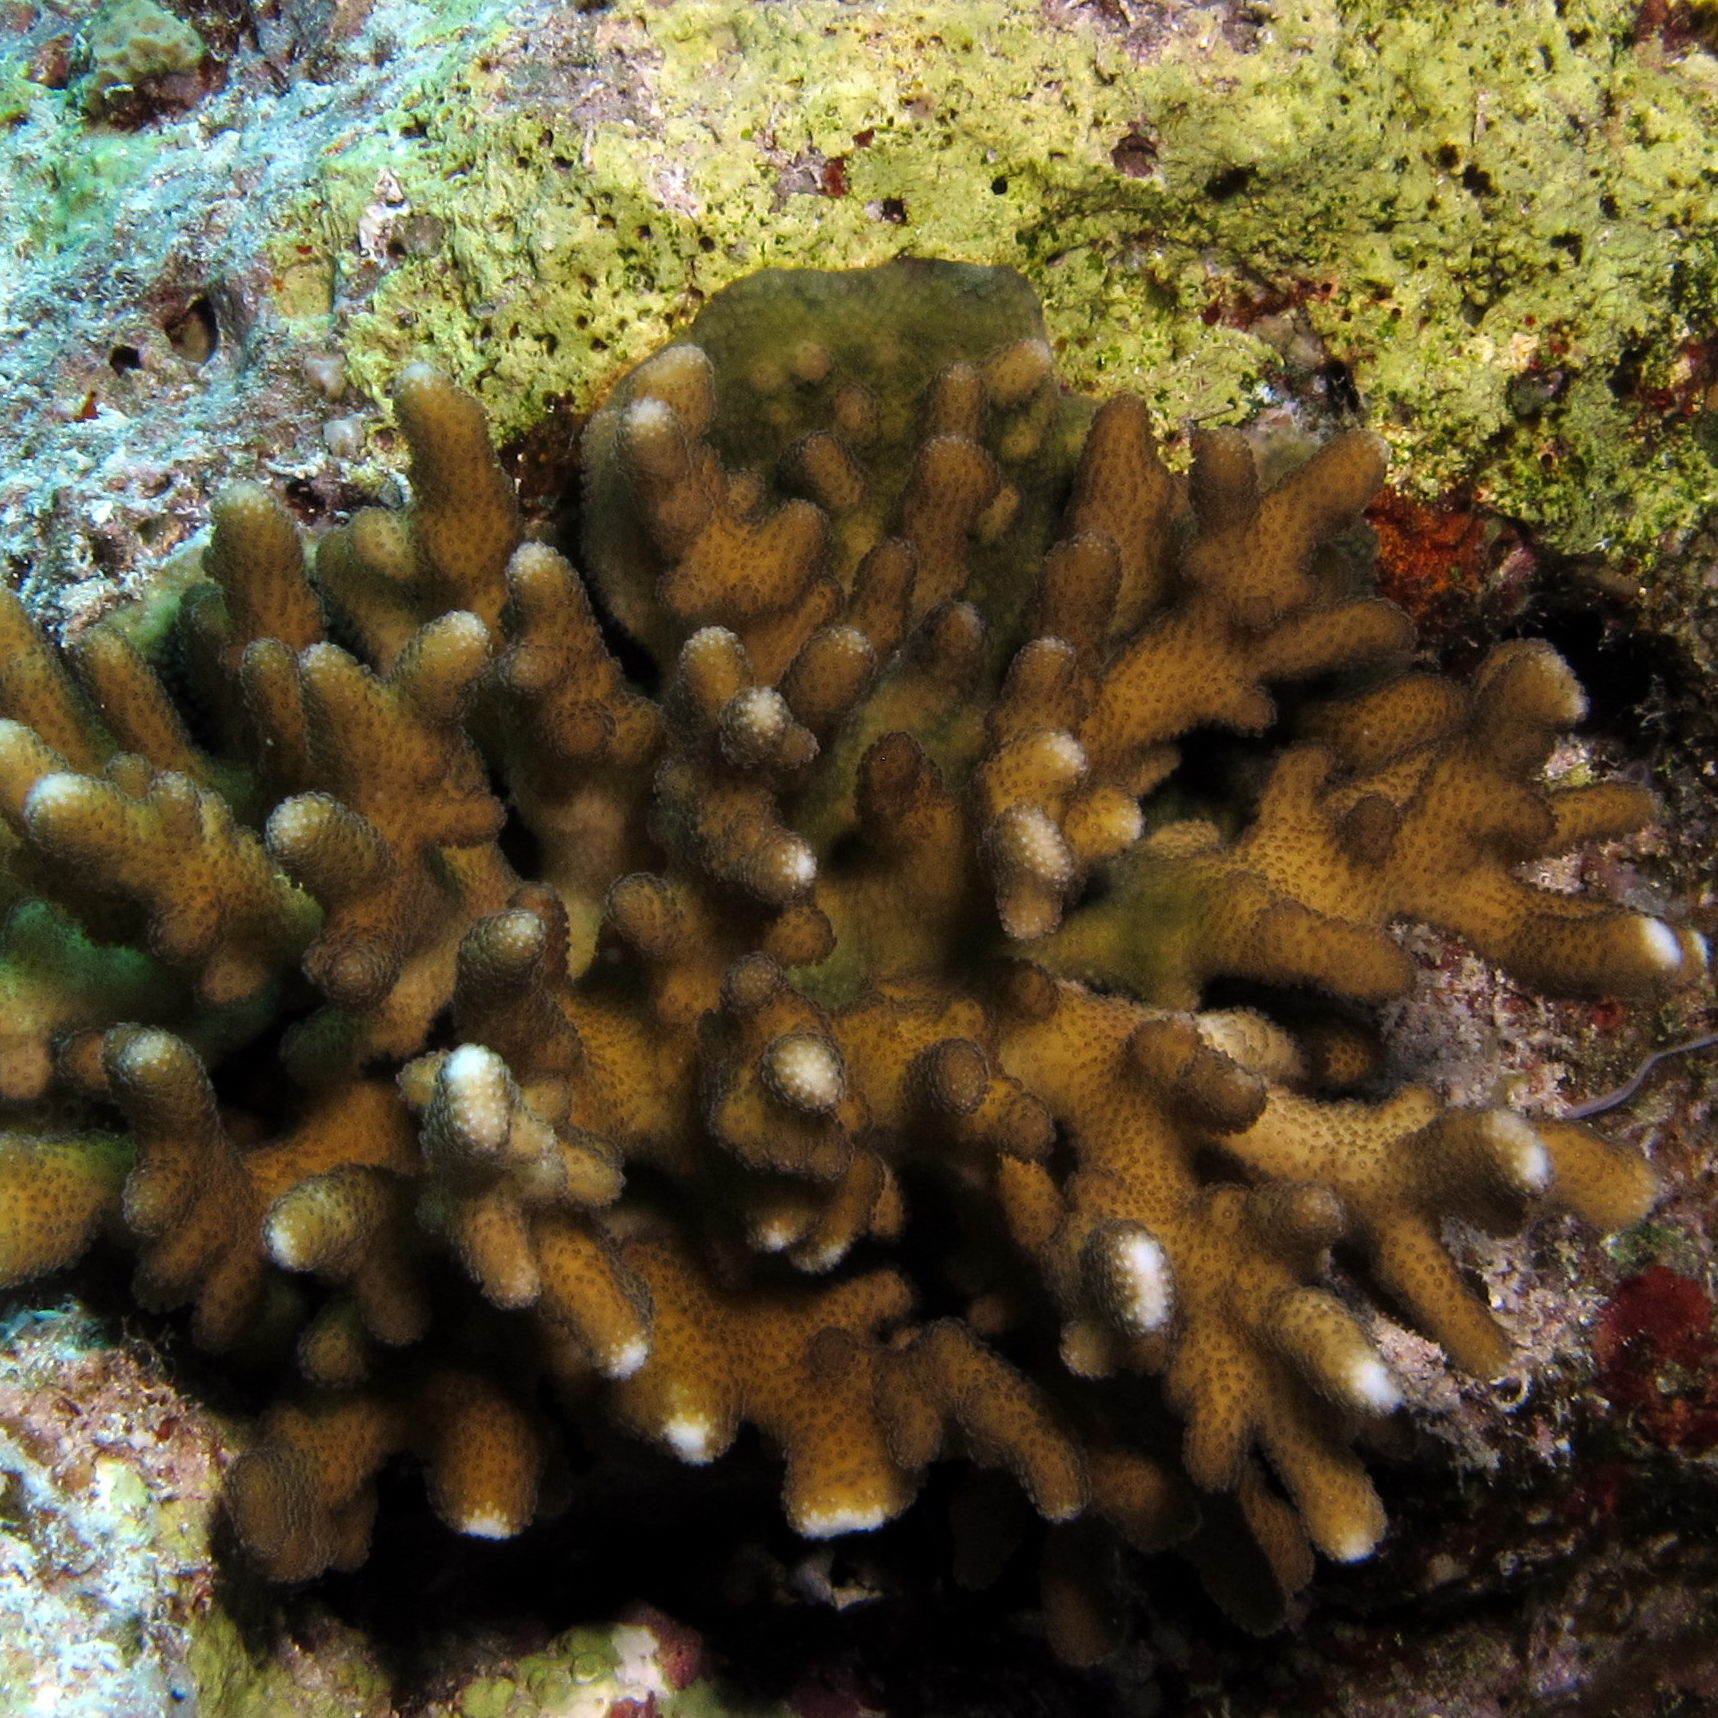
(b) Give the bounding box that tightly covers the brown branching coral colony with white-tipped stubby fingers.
[0,263,1704,1660]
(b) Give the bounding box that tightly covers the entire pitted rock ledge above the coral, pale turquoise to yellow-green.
[0,0,1718,611]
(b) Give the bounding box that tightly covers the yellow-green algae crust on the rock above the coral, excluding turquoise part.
[278,0,1718,553]
